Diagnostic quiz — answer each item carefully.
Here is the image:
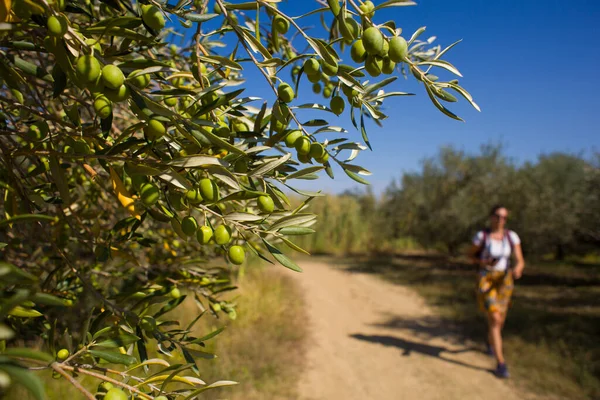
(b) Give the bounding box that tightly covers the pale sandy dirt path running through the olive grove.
[288,261,524,400]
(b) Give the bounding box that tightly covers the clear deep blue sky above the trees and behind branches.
[202,0,600,193]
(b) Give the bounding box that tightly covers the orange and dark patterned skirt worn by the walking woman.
[477,270,514,313]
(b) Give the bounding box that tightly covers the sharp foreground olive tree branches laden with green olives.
[0,0,478,400]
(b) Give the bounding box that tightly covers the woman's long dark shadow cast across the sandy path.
[350,333,494,373]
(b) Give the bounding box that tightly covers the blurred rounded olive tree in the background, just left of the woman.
[382,145,514,253]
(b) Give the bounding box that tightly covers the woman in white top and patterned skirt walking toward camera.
[470,205,525,378]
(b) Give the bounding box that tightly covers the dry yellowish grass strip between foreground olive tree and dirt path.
[171,267,306,400]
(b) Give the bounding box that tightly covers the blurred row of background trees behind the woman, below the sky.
[300,145,600,259]
